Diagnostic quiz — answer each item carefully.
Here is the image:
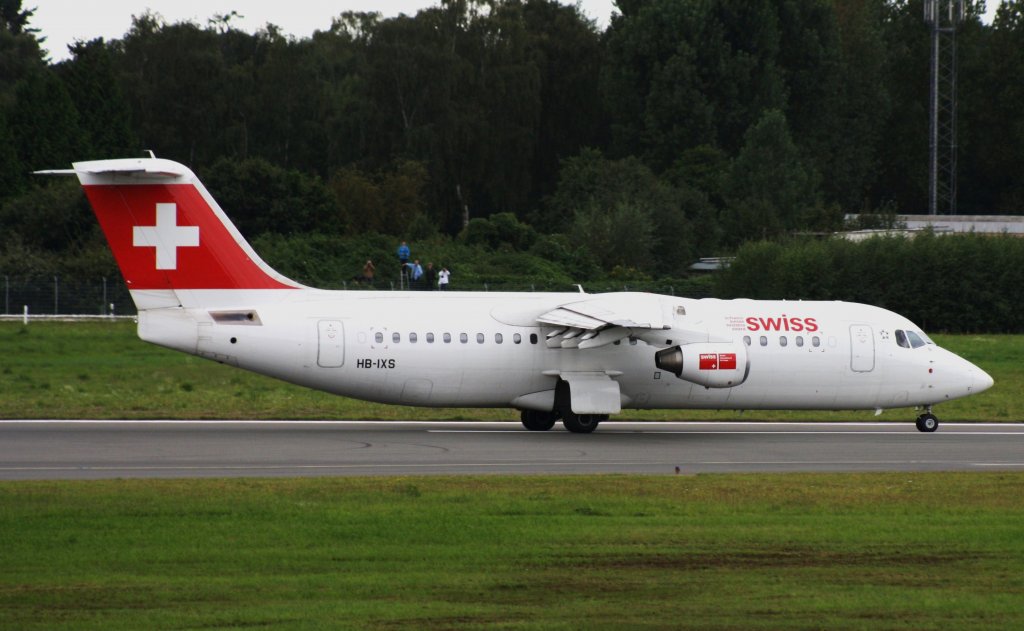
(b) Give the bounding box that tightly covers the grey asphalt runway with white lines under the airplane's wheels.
[0,421,1024,479]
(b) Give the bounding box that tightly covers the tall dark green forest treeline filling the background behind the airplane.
[0,0,1024,329]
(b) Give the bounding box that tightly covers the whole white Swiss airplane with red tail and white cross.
[40,157,993,433]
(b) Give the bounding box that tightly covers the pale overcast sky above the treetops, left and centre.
[32,0,614,61]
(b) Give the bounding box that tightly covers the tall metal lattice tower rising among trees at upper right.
[925,0,964,215]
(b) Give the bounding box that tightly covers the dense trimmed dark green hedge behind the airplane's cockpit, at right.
[718,234,1024,333]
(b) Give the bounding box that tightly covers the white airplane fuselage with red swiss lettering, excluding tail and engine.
[139,289,991,410]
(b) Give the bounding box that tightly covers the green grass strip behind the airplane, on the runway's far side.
[0,322,1024,421]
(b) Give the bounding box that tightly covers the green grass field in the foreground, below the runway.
[0,473,1024,629]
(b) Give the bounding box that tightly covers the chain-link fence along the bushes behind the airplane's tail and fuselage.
[0,276,712,317]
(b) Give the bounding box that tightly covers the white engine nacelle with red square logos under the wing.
[654,342,751,388]
